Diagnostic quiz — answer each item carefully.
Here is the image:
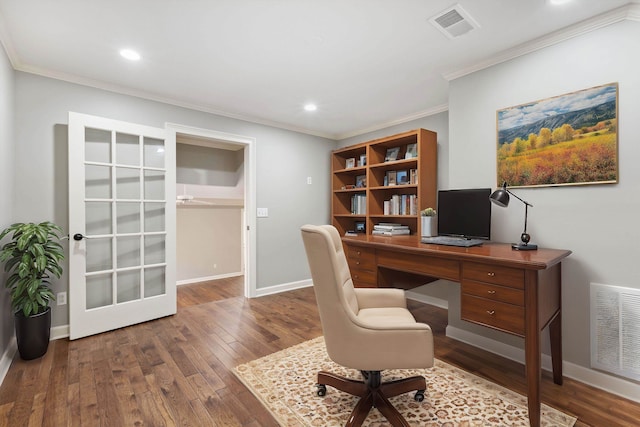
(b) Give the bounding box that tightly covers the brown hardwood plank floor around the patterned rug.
[0,279,640,427]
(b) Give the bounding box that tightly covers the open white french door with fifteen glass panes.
[69,112,176,339]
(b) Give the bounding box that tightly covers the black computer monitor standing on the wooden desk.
[437,188,491,240]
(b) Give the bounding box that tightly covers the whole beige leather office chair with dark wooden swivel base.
[302,225,433,426]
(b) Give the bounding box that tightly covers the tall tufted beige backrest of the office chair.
[301,225,359,355]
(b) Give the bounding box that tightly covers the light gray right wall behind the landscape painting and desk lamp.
[449,21,640,378]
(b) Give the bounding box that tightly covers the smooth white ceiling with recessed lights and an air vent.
[0,0,638,139]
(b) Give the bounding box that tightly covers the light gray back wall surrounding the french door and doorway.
[14,72,335,326]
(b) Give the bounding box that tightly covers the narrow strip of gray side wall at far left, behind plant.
[0,43,14,357]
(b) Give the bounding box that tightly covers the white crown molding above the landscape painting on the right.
[443,3,640,81]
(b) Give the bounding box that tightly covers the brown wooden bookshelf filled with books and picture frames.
[331,129,438,235]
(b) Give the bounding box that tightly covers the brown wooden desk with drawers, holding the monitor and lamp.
[342,235,571,427]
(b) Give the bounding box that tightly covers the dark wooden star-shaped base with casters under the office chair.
[318,371,427,427]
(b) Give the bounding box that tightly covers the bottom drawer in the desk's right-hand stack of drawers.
[460,293,524,336]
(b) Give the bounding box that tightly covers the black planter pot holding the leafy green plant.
[14,307,51,360]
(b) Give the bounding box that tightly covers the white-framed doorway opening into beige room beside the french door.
[167,124,256,298]
